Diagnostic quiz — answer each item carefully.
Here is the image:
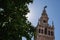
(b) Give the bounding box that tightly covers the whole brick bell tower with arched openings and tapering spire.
[35,6,55,40]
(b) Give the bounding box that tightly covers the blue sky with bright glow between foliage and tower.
[23,0,60,40]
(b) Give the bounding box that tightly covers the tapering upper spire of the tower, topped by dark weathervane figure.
[39,6,49,25]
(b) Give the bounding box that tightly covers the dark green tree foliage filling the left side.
[0,0,34,40]
